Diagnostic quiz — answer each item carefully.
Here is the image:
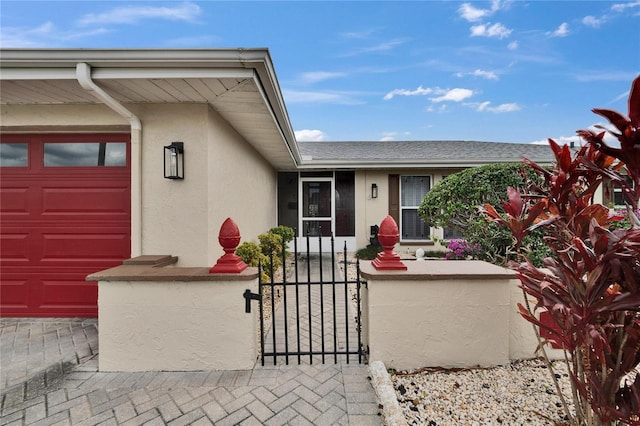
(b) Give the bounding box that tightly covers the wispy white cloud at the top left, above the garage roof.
[77,2,201,26]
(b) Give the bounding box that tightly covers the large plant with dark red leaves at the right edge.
[484,76,640,425]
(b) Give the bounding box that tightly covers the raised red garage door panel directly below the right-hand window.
[42,186,130,215]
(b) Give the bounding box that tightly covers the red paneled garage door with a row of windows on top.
[0,134,131,317]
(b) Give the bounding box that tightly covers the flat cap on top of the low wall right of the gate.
[360,260,516,281]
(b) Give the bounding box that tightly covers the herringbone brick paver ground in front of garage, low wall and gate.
[0,255,381,425]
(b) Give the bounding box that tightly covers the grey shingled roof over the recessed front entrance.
[298,141,554,168]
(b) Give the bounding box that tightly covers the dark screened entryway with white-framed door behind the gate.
[278,171,356,252]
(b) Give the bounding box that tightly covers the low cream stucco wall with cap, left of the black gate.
[88,255,259,371]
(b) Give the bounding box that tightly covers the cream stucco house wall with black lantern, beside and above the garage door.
[0,104,276,266]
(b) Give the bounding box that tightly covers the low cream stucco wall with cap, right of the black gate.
[361,260,560,370]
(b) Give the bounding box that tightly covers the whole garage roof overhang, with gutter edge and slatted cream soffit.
[0,49,299,169]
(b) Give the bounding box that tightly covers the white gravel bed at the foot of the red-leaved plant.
[391,360,572,426]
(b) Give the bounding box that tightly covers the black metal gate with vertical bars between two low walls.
[259,236,366,365]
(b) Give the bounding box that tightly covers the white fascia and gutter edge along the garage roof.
[0,48,301,166]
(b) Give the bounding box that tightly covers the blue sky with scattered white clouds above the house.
[0,0,640,143]
